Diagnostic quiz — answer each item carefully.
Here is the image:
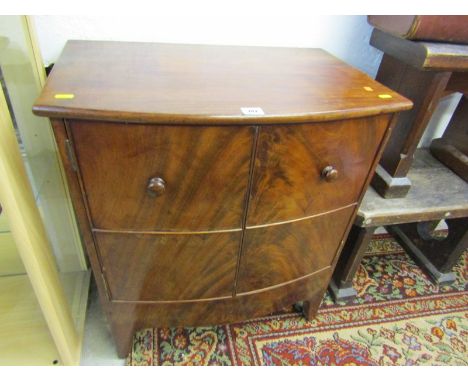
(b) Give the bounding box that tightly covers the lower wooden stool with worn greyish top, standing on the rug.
[330,149,468,301]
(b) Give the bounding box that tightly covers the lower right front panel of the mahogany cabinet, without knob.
[237,206,355,293]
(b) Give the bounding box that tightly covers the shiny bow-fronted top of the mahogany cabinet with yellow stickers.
[34,41,411,124]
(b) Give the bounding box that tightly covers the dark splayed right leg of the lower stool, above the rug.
[386,218,468,284]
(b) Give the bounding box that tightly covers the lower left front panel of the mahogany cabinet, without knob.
[95,231,241,301]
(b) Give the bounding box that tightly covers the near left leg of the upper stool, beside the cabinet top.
[372,54,451,198]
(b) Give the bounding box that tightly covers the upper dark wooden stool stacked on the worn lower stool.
[370,29,468,198]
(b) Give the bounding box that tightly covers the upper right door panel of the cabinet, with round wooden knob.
[247,115,389,226]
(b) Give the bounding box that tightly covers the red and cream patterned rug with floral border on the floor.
[127,235,468,365]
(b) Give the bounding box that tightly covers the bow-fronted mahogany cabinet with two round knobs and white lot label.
[34,41,411,357]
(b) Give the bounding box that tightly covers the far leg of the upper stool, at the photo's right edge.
[431,95,468,182]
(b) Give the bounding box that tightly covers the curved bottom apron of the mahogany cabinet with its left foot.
[109,268,331,358]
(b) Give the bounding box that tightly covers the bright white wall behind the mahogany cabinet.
[34,14,459,146]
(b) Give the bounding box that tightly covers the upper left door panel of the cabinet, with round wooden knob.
[68,121,253,231]
